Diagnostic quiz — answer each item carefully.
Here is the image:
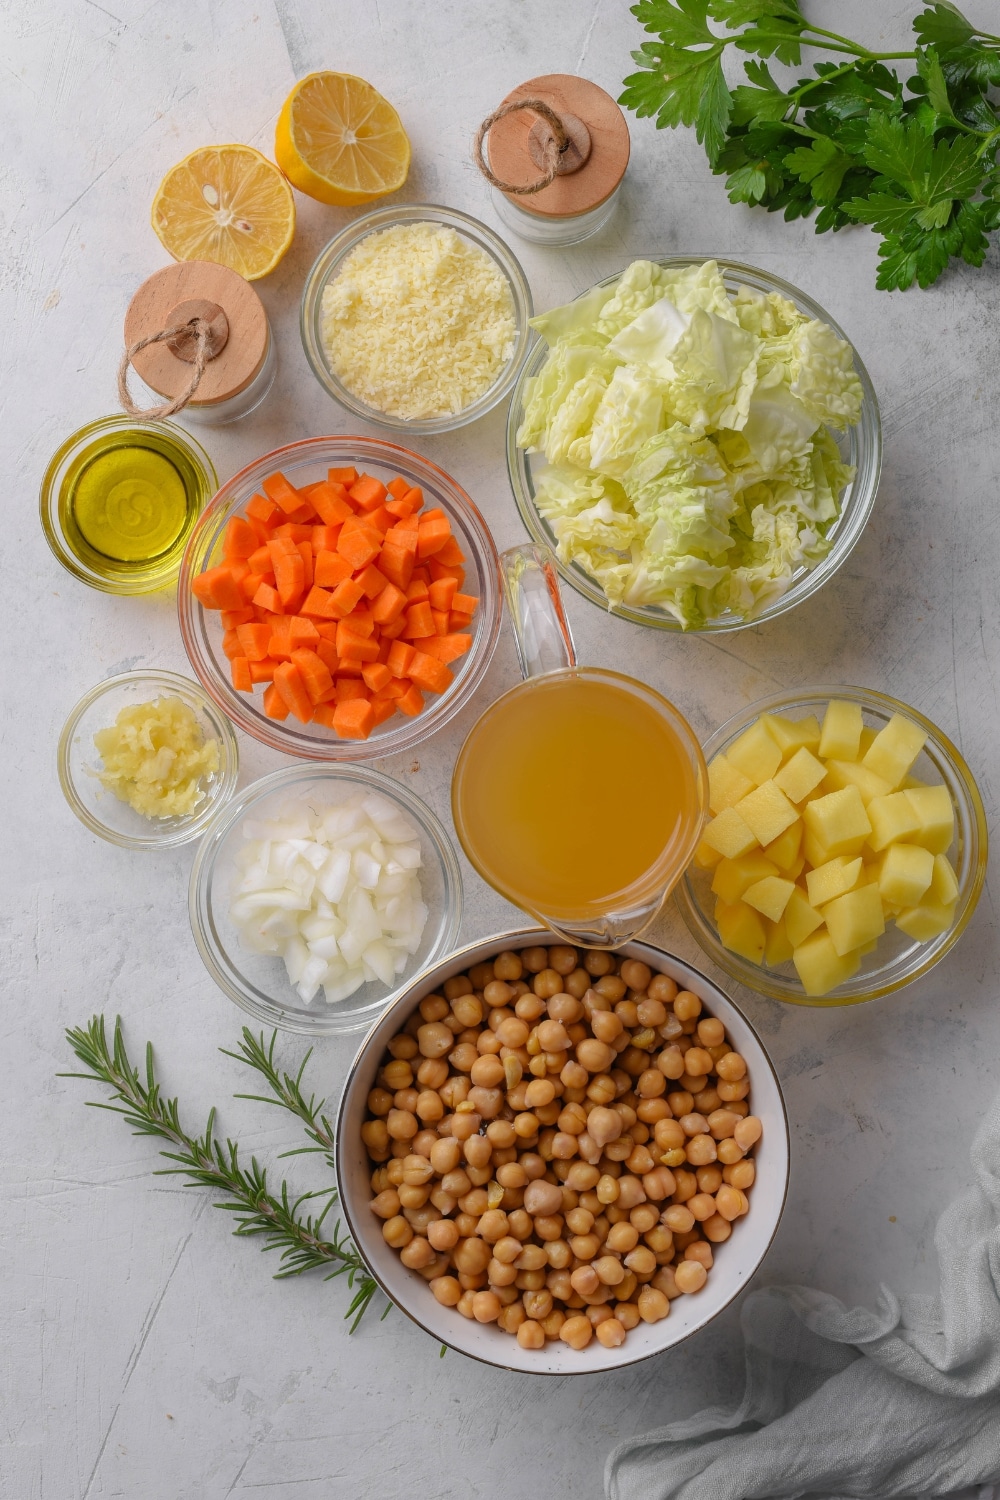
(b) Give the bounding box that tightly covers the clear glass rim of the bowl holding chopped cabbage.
[507,252,883,636]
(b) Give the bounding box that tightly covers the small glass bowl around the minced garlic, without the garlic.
[57,672,240,849]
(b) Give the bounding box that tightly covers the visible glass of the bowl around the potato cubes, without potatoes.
[675,686,988,1007]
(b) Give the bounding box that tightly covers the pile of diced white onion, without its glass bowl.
[229,792,427,1005]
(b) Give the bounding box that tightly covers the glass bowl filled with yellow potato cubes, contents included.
[676,686,988,1005]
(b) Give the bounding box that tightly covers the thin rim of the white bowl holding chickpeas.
[334,926,792,1379]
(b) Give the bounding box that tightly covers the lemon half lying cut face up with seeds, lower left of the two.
[153,146,295,281]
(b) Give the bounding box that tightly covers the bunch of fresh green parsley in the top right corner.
[621,0,1000,291]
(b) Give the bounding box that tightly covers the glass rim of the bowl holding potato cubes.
[673,683,990,1010]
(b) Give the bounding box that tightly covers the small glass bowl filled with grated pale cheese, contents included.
[301,204,532,434]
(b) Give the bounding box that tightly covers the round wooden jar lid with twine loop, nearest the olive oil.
[124,261,270,407]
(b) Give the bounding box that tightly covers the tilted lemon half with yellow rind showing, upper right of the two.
[274,74,409,204]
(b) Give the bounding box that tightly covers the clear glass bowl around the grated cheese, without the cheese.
[300,203,534,434]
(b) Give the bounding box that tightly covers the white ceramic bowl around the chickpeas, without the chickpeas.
[336,927,789,1376]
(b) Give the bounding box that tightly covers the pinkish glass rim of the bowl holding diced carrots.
[177,432,502,765]
